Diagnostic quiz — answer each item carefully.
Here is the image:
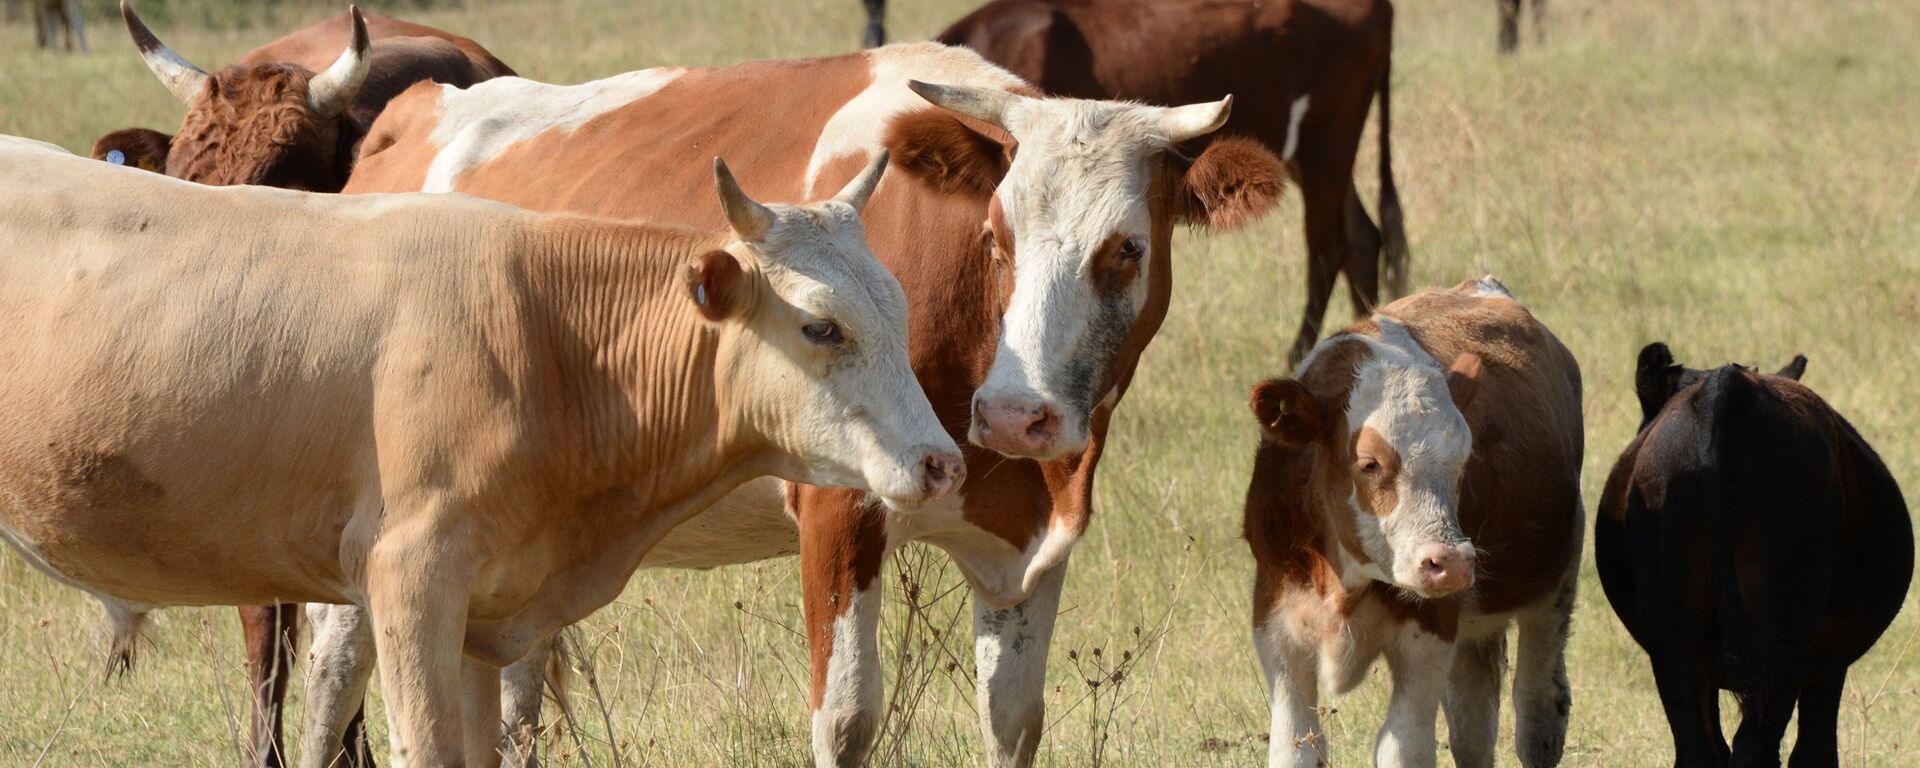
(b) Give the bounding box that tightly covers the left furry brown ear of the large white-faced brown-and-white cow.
[887,109,1008,196]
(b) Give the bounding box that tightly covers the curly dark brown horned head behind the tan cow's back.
[114,2,371,192]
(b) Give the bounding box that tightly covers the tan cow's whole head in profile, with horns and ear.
[702,154,966,501]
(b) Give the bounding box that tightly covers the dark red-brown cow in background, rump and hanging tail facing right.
[939,0,1407,363]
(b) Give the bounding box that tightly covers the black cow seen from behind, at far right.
[1594,344,1914,768]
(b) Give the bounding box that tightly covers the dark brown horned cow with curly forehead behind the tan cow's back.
[92,0,513,192]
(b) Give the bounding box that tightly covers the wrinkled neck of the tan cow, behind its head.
[524,217,760,509]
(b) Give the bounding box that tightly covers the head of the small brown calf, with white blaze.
[1252,334,1480,597]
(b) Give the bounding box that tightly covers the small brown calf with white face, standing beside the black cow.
[1246,278,1584,768]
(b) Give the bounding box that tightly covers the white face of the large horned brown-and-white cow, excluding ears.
[970,98,1225,459]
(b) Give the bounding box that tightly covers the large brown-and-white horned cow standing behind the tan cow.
[337,44,1284,764]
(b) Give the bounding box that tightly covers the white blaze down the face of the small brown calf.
[1346,319,1473,595]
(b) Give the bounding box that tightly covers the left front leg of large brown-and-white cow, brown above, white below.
[799,503,887,766]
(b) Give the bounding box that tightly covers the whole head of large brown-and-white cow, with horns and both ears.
[895,83,1283,459]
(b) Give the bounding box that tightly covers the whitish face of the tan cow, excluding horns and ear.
[722,194,960,501]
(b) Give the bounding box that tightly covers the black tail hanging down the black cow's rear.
[1697,365,1753,676]
